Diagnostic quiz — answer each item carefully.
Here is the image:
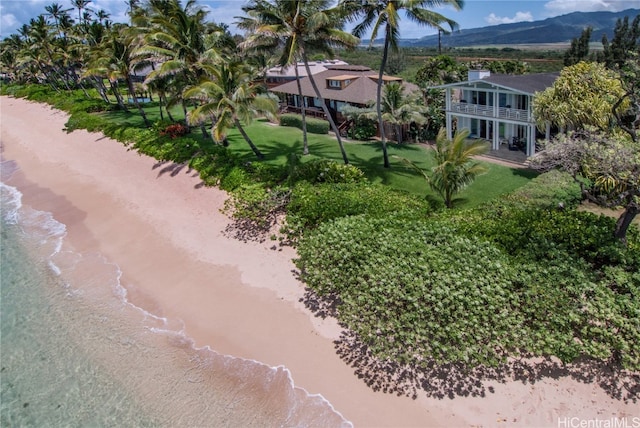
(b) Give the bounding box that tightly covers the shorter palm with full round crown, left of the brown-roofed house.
[183,58,278,159]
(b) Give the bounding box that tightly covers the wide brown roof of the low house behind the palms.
[271,65,418,104]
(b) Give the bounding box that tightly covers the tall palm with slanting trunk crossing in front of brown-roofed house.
[239,0,359,164]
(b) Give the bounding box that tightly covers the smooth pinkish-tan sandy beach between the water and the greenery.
[0,96,640,427]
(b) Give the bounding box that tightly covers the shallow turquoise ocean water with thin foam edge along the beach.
[0,162,351,427]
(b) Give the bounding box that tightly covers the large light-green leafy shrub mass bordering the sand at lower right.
[296,215,640,370]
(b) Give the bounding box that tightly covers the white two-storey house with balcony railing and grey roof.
[433,70,559,156]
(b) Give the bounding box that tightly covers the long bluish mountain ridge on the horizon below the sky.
[398,9,640,47]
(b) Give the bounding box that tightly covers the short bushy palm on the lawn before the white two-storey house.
[427,128,487,208]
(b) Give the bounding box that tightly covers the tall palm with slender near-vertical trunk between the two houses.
[339,0,464,168]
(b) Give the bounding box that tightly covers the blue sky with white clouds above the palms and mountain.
[0,0,640,39]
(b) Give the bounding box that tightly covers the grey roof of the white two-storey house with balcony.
[432,73,560,95]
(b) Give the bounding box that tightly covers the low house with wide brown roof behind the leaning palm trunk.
[271,64,419,130]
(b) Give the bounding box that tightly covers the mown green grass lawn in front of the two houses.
[104,106,536,208]
